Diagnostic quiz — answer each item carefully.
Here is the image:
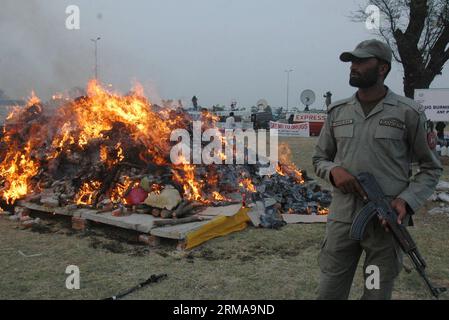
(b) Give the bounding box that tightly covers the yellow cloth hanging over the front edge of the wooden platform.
[185,208,251,249]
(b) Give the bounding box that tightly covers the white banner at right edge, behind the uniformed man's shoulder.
[415,89,449,122]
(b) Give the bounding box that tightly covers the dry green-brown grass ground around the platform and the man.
[0,138,449,299]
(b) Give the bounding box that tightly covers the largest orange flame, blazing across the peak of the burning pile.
[48,80,186,164]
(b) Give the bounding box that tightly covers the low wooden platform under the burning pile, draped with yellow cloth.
[14,201,327,250]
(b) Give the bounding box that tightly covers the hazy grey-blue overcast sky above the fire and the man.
[0,0,449,108]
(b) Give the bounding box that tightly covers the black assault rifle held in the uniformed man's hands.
[350,172,447,299]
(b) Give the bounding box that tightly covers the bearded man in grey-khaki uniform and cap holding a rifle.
[313,40,442,299]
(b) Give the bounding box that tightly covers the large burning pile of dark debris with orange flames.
[0,81,330,217]
